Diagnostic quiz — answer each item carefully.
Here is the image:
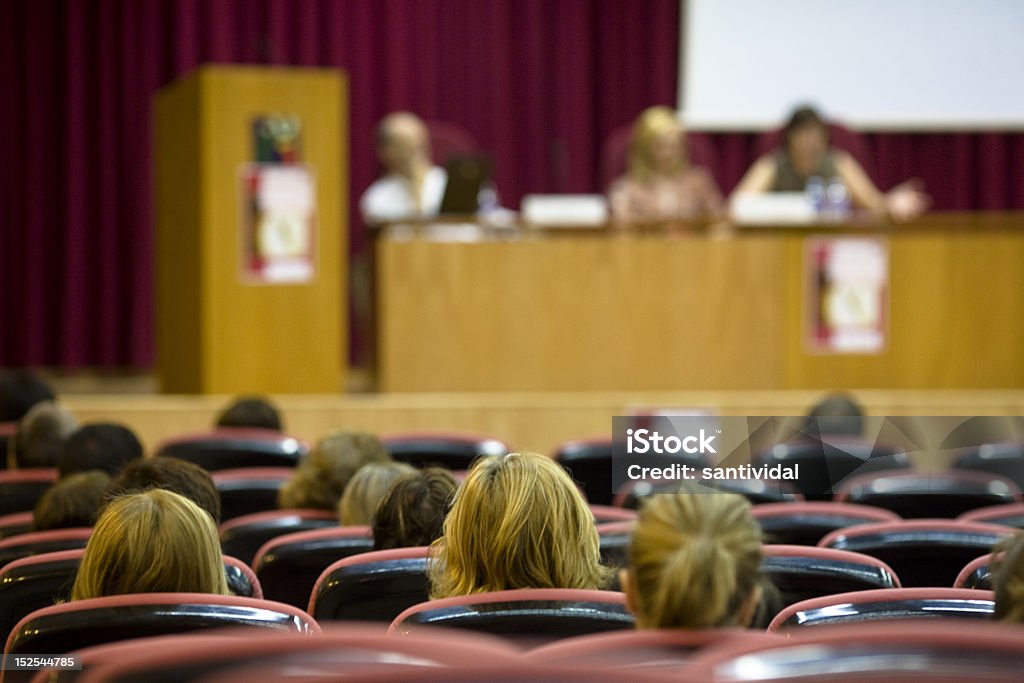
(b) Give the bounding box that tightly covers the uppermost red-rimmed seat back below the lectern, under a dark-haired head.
[155,427,309,472]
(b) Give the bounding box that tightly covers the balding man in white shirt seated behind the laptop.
[359,112,447,224]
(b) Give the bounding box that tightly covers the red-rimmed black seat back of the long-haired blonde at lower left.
[4,593,321,654]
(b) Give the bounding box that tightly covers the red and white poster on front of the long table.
[804,237,889,353]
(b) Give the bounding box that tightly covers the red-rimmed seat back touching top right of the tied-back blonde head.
[753,501,900,546]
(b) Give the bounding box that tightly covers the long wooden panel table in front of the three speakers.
[377,213,1024,391]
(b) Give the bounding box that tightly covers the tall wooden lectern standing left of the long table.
[155,66,348,393]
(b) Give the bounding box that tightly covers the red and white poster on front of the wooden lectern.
[239,164,316,285]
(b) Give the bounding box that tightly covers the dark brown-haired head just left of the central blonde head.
[372,467,458,550]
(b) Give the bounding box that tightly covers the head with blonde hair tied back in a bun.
[620,493,762,629]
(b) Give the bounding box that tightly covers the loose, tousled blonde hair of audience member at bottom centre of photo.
[429,453,609,598]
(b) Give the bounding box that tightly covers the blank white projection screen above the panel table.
[679,0,1024,130]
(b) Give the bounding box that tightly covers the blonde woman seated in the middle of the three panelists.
[608,106,724,226]
